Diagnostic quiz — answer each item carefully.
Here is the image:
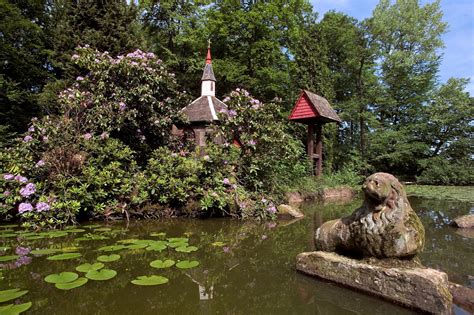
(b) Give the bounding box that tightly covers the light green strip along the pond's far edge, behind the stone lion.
[405,185,474,203]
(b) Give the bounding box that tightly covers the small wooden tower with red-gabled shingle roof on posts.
[289,90,341,176]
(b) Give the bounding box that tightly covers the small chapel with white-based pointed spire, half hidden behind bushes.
[173,43,227,147]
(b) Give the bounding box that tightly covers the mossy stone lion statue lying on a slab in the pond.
[315,173,425,258]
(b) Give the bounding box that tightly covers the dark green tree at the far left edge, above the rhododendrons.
[0,1,50,146]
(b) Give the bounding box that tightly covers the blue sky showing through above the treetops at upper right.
[311,0,474,96]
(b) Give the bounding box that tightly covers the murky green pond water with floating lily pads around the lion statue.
[0,198,474,314]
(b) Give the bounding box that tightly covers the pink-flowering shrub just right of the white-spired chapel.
[218,89,306,193]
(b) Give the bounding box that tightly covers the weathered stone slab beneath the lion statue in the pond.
[296,251,452,314]
